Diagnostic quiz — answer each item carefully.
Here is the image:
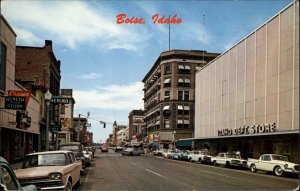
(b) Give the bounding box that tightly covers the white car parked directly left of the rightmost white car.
[211,152,247,168]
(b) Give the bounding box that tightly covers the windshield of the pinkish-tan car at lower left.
[22,153,66,168]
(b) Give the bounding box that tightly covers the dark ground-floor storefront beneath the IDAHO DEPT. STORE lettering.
[185,131,299,162]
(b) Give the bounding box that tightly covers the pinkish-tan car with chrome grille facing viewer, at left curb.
[15,150,82,190]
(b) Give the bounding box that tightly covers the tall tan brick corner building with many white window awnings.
[143,50,219,148]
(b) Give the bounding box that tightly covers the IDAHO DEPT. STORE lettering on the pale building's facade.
[218,122,278,136]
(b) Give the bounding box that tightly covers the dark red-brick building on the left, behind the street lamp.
[15,40,61,150]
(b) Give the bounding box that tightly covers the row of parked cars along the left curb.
[0,142,95,191]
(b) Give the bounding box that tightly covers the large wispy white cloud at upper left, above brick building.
[1,1,146,51]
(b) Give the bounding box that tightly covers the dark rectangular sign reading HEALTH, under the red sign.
[4,96,26,110]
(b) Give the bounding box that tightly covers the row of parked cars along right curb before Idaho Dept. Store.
[153,150,300,176]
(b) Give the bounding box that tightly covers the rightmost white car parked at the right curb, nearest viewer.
[247,154,299,176]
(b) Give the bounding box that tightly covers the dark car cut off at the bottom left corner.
[0,157,37,191]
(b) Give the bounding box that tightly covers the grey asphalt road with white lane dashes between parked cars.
[76,150,298,191]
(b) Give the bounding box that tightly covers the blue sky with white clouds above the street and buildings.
[1,0,293,142]
